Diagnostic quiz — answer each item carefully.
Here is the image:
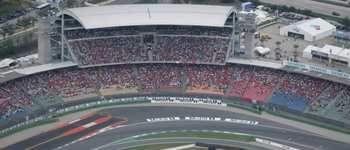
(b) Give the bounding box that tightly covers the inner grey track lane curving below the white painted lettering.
[63,121,349,150]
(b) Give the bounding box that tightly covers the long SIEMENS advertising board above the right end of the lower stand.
[283,60,350,80]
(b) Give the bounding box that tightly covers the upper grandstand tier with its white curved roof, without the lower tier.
[57,5,235,67]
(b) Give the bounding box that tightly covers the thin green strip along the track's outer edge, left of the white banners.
[52,100,151,118]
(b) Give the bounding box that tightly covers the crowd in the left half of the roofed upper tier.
[69,36,148,65]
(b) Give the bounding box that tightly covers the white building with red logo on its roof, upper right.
[280,18,336,42]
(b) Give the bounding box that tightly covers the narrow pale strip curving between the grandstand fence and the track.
[0,104,350,148]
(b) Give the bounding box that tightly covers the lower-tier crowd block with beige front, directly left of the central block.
[87,65,137,90]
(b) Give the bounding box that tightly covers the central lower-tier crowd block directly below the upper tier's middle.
[138,64,184,93]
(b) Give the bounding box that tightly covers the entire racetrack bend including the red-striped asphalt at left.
[6,106,350,150]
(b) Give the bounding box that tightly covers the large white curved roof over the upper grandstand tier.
[57,4,236,29]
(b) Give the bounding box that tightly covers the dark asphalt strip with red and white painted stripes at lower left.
[4,113,123,150]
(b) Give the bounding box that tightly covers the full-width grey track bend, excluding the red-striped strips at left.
[62,106,350,150]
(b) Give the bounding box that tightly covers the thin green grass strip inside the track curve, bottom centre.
[135,132,255,142]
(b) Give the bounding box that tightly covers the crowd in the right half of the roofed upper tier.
[152,36,228,63]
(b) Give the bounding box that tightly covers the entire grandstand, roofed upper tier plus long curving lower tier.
[0,5,350,132]
